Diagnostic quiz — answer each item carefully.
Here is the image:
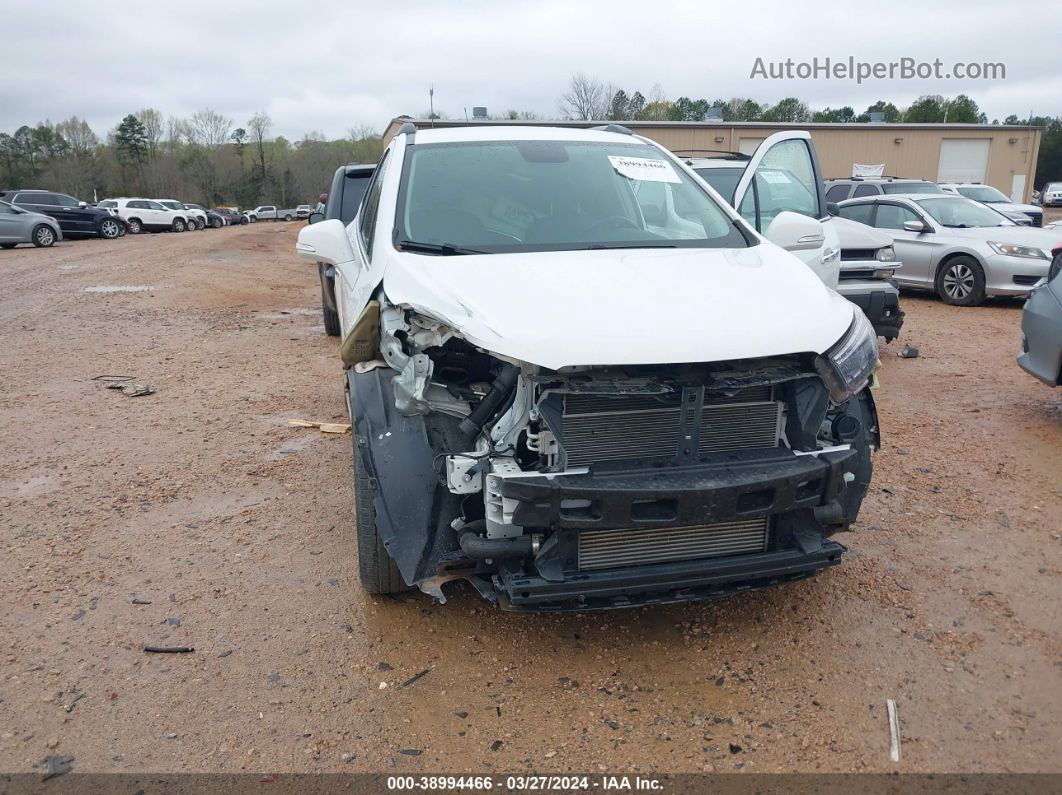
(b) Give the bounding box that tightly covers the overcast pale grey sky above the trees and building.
[0,0,1062,139]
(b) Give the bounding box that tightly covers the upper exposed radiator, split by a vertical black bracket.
[561,386,782,467]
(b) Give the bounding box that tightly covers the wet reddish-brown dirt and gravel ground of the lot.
[0,218,1062,773]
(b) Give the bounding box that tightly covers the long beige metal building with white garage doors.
[384,118,1041,202]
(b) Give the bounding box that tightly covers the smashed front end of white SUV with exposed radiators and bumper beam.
[344,293,879,611]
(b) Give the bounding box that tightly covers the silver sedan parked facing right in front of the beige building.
[840,193,1062,307]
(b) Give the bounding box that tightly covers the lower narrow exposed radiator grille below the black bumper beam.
[579,516,770,570]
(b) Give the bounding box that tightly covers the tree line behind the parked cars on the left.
[0,108,382,207]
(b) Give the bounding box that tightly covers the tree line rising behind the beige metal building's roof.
[558,73,1062,187]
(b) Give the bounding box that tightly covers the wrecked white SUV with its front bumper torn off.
[296,123,879,611]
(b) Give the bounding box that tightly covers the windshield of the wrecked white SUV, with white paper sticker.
[395,141,749,254]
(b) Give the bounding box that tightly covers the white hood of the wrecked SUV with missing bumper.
[383,243,853,369]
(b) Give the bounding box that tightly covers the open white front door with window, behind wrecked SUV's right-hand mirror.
[734,129,841,288]
